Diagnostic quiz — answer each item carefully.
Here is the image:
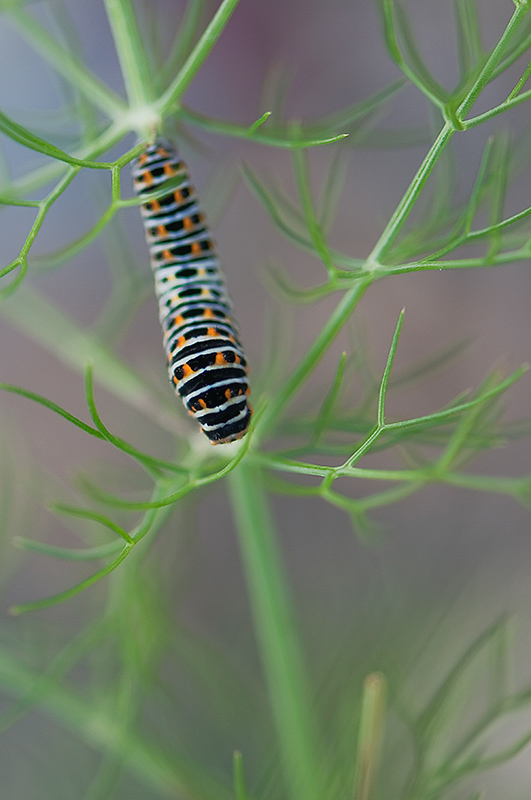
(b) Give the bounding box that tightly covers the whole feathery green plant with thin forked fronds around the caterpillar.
[0,0,531,800]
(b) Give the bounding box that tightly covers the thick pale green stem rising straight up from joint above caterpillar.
[104,0,154,108]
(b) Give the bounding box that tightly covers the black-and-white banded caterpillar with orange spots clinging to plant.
[132,138,252,444]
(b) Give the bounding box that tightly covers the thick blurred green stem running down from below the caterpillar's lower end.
[229,461,323,800]
